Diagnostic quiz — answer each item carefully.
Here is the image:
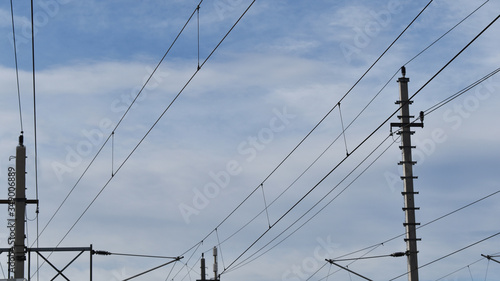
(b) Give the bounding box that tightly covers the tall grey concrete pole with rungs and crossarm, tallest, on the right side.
[391,66,424,281]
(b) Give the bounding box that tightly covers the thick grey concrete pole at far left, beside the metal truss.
[14,135,26,278]
